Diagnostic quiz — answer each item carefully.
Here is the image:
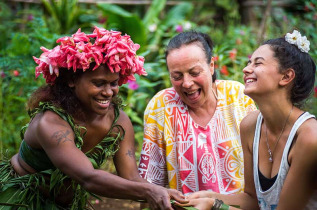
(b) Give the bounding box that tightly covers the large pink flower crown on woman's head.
[33,27,147,85]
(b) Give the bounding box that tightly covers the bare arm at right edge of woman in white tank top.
[277,119,317,210]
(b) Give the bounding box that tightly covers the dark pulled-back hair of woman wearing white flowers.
[262,38,316,107]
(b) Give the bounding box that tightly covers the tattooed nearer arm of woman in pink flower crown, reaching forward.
[34,112,180,209]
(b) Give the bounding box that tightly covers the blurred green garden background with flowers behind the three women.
[0,0,317,162]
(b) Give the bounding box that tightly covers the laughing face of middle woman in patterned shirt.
[166,42,214,108]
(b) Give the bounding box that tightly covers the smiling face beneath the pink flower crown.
[69,66,119,115]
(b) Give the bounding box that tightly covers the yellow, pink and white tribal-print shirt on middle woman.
[139,80,256,194]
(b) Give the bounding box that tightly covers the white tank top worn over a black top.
[253,112,317,210]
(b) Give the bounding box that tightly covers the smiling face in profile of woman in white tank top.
[243,45,283,98]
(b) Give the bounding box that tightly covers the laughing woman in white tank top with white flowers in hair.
[177,30,317,210]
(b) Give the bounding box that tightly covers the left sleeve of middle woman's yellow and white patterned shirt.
[139,92,168,187]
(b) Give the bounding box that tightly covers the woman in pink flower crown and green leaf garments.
[0,27,184,209]
